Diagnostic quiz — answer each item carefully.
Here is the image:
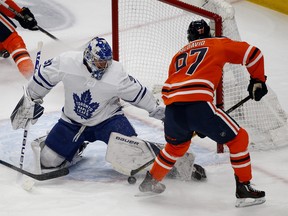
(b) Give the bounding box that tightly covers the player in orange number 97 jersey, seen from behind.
[139,20,268,207]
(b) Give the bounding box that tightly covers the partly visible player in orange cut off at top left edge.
[0,0,38,79]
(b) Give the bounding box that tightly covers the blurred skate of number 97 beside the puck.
[139,171,166,194]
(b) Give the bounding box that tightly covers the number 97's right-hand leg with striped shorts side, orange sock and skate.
[199,103,265,207]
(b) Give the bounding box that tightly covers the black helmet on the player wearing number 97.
[187,19,211,42]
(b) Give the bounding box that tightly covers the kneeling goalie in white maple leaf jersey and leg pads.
[11,37,206,180]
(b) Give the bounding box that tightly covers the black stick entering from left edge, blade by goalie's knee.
[0,160,69,181]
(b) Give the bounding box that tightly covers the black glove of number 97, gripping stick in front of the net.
[247,77,268,101]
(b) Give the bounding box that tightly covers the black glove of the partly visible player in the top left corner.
[15,7,38,31]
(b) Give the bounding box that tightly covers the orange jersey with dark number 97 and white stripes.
[162,38,265,105]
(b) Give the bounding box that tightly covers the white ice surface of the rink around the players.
[0,0,288,216]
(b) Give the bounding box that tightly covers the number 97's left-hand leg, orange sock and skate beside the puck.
[139,105,193,193]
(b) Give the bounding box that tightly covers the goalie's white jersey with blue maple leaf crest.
[27,51,156,126]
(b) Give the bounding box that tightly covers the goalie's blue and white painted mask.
[83,37,112,80]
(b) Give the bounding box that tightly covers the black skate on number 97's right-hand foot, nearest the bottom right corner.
[235,176,266,208]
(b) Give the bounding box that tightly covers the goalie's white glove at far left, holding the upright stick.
[10,88,44,130]
